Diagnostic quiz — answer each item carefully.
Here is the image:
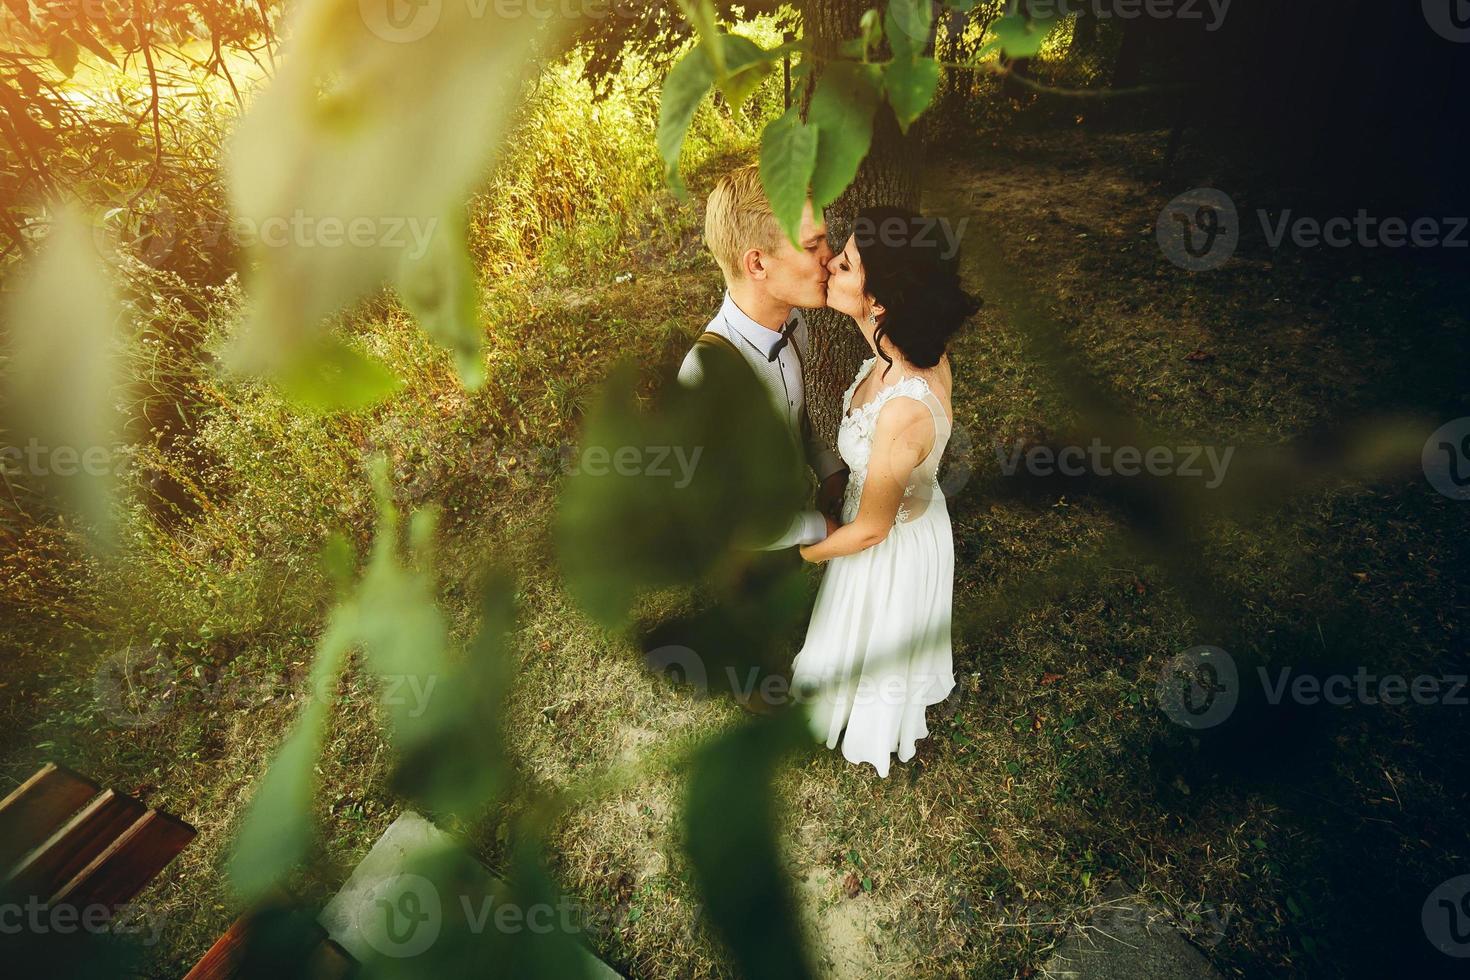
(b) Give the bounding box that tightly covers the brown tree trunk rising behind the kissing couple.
[801,0,923,445]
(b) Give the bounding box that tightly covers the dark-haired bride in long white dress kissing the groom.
[792,209,979,777]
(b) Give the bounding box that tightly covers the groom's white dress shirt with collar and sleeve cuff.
[679,292,847,551]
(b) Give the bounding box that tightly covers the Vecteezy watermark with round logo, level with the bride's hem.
[1157,646,1470,729]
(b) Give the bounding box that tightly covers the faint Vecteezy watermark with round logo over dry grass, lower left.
[93,645,440,729]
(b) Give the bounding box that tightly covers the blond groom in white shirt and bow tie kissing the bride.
[679,166,847,551]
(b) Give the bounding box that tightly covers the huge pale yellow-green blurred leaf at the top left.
[228,0,569,373]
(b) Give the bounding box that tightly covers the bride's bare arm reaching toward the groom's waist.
[801,398,933,561]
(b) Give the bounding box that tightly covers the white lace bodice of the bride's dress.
[836,357,951,525]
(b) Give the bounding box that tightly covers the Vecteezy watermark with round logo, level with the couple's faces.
[1154,187,1470,272]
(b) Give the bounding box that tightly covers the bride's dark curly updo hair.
[853,207,980,373]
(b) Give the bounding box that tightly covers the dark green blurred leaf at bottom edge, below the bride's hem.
[682,711,811,980]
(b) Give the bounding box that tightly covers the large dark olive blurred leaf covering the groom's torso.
[556,350,807,626]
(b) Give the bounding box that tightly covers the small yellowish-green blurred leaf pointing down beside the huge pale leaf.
[398,209,485,388]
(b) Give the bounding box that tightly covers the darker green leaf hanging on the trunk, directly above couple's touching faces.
[807,62,882,212]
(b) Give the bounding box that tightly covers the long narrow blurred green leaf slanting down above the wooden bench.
[229,605,356,905]
